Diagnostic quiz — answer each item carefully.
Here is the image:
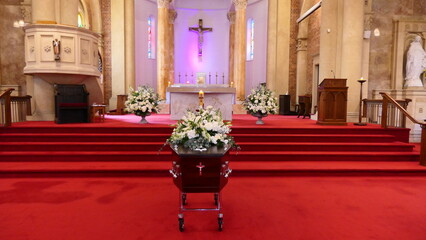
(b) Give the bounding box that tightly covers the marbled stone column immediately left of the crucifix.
[157,0,170,99]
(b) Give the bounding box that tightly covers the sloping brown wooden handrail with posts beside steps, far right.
[380,92,426,166]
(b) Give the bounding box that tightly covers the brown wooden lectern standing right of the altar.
[317,78,348,125]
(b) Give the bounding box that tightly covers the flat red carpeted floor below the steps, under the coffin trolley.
[0,177,426,240]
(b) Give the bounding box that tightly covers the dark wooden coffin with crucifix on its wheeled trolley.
[169,145,232,232]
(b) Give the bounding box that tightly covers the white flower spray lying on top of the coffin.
[167,106,235,151]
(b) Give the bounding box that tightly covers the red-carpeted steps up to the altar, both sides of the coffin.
[0,115,426,177]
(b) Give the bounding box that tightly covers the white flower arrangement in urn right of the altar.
[243,84,278,124]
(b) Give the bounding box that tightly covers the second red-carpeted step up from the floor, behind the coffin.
[0,151,419,162]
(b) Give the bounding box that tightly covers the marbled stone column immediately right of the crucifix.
[232,0,247,101]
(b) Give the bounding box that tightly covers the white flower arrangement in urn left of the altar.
[124,86,160,123]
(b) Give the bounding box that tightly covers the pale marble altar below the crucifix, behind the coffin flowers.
[166,84,236,120]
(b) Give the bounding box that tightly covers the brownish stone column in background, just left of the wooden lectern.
[296,38,308,100]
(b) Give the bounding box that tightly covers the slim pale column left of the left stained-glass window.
[124,0,136,93]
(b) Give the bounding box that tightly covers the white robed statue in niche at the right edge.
[404,36,426,87]
